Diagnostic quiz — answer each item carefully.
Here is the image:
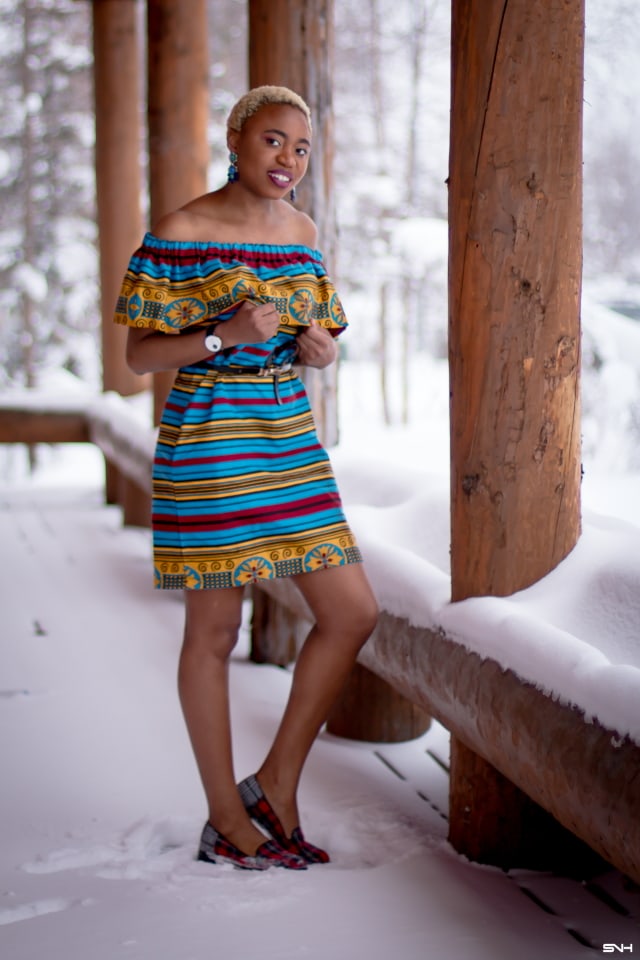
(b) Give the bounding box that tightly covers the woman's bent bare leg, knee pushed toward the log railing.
[252,564,378,836]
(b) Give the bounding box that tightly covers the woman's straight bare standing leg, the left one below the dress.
[178,588,265,855]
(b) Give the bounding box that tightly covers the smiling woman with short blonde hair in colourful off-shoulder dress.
[115,86,377,869]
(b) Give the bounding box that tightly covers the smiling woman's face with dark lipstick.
[228,103,311,199]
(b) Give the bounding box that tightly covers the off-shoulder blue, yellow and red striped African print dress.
[115,233,362,589]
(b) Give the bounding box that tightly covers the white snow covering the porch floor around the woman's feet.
[0,484,640,960]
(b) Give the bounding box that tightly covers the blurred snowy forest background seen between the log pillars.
[0,0,640,469]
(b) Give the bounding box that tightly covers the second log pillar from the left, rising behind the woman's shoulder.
[147,0,208,423]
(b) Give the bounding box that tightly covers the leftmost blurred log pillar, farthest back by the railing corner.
[91,0,150,503]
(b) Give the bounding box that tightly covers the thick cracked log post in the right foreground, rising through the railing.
[449,0,584,866]
